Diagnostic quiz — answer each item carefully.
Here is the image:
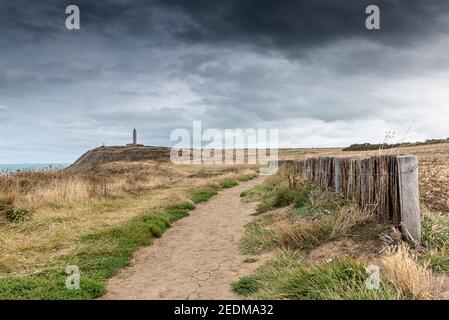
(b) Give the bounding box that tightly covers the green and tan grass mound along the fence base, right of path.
[241,182,372,254]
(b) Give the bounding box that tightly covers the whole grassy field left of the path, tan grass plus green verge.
[0,162,255,299]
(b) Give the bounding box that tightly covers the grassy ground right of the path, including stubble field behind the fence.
[233,144,449,300]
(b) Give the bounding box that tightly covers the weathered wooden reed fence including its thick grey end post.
[272,155,421,242]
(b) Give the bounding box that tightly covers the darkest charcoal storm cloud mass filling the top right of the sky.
[152,0,449,54]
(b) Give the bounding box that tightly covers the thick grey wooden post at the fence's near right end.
[397,155,421,242]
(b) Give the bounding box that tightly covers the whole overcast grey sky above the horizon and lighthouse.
[0,0,449,163]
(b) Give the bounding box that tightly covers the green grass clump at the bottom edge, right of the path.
[232,251,407,300]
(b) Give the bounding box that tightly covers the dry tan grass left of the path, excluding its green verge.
[0,162,253,275]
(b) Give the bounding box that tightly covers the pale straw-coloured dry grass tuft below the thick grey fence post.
[381,245,432,300]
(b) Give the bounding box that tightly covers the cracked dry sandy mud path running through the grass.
[102,178,263,299]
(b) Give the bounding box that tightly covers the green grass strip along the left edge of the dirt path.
[0,209,189,300]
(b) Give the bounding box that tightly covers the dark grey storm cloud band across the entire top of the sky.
[0,0,449,50]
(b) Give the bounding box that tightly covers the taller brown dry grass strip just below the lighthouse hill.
[0,162,187,210]
